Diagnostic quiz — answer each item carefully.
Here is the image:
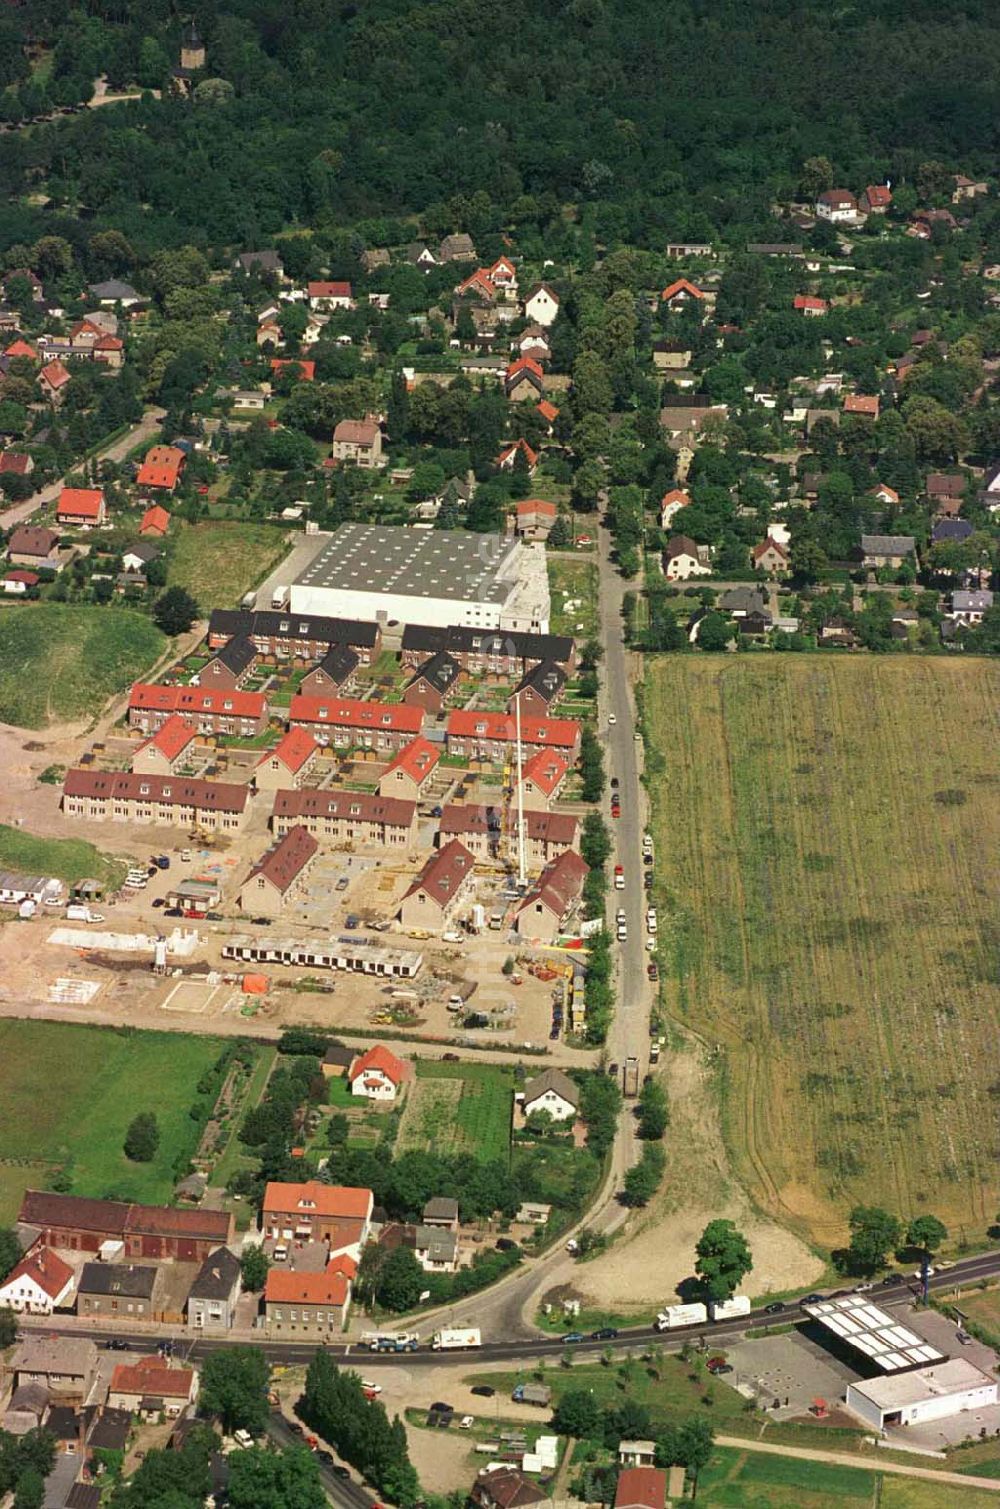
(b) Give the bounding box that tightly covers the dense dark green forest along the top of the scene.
[0,0,1000,246]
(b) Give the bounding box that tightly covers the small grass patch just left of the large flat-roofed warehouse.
[169,521,285,617]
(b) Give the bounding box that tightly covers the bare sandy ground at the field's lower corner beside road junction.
[573,1038,824,1311]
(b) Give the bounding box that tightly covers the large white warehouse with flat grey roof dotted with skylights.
[291,524,549,634]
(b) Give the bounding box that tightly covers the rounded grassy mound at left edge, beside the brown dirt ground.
[0,602,166,729]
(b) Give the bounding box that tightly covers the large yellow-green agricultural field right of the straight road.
[646,655,1000,1245]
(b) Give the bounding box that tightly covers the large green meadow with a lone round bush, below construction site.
[0,1020,223,1224]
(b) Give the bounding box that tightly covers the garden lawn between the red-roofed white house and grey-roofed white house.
[395,1059,514,1163]
